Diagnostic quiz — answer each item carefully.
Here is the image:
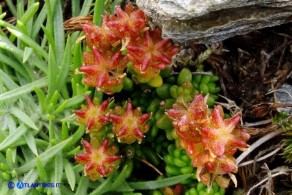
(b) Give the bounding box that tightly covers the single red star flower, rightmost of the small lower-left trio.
[109,100,151,144]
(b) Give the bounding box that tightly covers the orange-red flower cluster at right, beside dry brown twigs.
[167,94,249,188]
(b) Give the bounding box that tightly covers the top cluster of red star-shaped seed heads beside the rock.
[79,5,178,94]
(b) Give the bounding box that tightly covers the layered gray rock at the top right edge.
[136,0,292,44]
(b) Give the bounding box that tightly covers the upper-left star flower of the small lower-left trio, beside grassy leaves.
[75,95,109,133]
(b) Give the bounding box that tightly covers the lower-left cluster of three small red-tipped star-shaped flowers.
[75,96,151,180]
